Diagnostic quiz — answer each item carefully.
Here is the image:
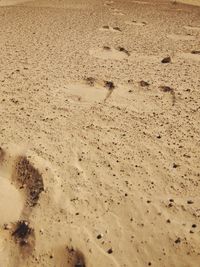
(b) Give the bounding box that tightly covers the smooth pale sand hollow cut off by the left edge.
[0,176,23,225]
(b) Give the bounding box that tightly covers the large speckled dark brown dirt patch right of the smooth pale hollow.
[14,157,44,206]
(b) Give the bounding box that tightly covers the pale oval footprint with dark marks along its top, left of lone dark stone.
[89,46,130,60]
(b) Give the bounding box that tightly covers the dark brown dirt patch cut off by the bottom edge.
[66,247,86,267]
